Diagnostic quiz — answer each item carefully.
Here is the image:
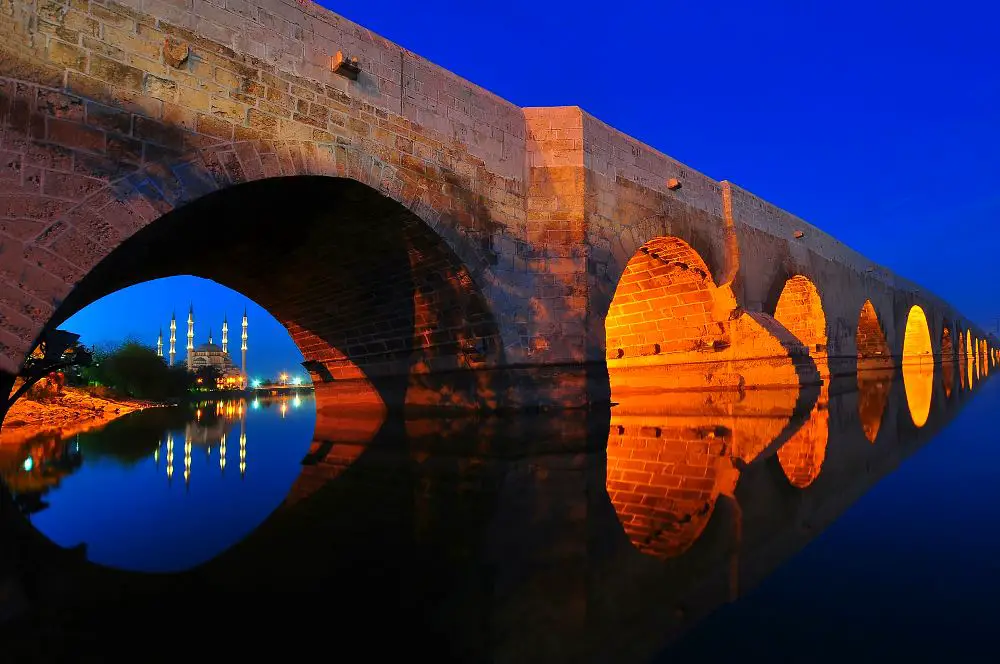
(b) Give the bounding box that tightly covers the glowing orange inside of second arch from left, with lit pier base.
[605,236,802,412]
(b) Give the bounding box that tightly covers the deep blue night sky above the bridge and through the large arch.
[64,0,1000,358]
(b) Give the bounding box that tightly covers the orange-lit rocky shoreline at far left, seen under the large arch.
[0,387,173,445]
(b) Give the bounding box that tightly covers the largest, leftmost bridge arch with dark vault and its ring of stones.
[28,148,505,410]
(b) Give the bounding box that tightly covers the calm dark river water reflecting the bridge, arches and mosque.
[0,365,1000,662]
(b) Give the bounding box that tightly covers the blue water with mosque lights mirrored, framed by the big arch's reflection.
[0,396,315,571]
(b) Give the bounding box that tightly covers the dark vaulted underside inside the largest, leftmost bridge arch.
[39,176,503,412]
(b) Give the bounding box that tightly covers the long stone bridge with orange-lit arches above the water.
[0,0,995,411]
